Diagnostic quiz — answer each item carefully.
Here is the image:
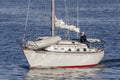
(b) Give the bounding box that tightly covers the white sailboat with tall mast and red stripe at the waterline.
[23,0,104,68]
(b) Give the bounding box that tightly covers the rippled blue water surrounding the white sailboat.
[0,0,120,80]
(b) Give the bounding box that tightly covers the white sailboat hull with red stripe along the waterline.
[23,49,104,68]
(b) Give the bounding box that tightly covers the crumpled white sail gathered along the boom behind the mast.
[55,17,80,33]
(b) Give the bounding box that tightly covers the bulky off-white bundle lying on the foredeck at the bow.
[26,36,61,49]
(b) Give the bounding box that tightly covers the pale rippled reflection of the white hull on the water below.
[26,65,102,80]
